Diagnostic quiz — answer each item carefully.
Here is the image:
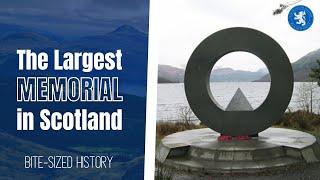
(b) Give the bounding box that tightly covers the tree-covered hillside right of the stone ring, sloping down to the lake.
[257,49,320,82]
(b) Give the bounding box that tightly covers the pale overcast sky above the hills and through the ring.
[155,0,320,71]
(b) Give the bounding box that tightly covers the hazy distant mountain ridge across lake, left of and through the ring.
[158,65,265,83]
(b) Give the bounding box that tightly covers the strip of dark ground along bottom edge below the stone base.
[173,163,320,180]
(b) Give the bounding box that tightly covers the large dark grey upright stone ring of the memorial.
[184,27,293,136]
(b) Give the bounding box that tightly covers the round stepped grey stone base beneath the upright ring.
[156,128,320,175]
